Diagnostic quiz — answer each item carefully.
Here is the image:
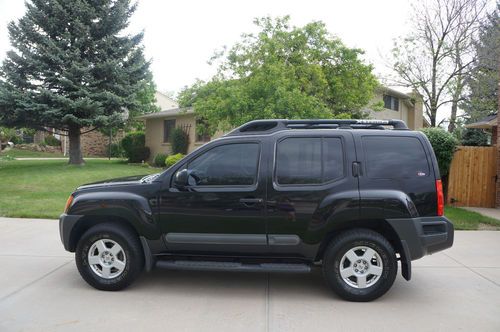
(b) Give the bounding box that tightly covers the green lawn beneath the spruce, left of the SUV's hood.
[0,160,160,218]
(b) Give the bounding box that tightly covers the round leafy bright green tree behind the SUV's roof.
[179,17,377,132]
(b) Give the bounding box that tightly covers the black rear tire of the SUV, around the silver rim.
[323,229,398,302]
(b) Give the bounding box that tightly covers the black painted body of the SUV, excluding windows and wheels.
[60,129,453,280]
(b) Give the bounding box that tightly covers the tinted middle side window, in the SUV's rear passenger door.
[276,137,344,185]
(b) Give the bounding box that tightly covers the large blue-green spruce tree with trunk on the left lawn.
[0,0,151,164]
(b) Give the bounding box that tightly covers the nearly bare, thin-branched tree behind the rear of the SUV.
[393,0,486,131]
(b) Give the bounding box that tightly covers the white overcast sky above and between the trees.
[0,0,411,93]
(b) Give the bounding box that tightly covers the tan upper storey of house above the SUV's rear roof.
[366,86,430,130]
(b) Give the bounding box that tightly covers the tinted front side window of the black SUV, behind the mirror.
[187,143,260,186]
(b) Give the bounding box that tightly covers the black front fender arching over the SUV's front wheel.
[68,191,160,239]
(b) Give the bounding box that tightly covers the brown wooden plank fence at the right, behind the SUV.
[447,146,497,207]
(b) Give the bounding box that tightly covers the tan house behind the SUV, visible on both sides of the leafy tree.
[137,87,428,160]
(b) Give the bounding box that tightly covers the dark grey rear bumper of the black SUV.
[387,217,454,260]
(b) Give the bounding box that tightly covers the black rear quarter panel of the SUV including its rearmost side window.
[355,130,436,219]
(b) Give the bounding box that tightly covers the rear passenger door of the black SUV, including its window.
[267,129,359,259]
